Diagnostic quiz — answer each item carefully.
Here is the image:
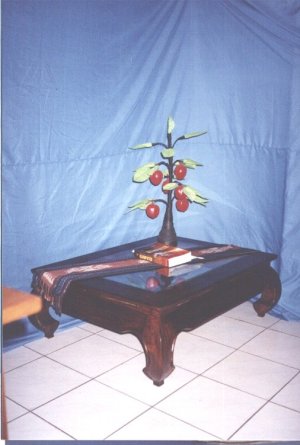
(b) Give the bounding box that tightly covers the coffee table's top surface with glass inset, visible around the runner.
[71,237,276,302]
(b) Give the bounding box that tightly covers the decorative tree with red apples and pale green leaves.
[129,117,208,246]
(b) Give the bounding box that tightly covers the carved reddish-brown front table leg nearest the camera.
[139,315,177,386]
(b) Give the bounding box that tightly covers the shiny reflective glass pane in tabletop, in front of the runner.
[103,257,237,293]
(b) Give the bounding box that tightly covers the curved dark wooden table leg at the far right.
[253,267,281,317]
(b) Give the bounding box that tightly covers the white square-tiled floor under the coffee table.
[3,303,300,441]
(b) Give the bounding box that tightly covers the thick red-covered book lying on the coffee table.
[134,243,193,267]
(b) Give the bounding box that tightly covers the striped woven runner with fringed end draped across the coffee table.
[32,245,255,315]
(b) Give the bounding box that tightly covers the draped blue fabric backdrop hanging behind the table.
[2,0,300,346]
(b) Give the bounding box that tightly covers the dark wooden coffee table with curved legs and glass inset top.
[30,238,281,386]
